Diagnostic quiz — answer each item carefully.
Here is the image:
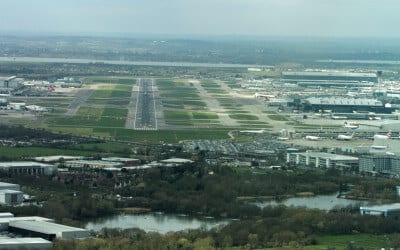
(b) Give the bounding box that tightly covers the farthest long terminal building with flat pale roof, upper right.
[282,71,378,83]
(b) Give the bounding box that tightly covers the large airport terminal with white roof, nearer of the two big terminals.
[302,96,395,113]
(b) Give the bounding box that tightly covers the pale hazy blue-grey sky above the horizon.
[0,0,400,38]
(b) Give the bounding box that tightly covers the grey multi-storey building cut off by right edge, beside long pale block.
[359,155,400,175]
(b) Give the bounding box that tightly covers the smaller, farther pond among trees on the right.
[251,193,371,210]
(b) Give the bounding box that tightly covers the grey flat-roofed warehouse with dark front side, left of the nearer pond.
[8,220,90,240]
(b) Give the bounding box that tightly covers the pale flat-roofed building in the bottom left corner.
[0,237,53,249]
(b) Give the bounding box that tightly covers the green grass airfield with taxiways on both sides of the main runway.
[10,77,284,141]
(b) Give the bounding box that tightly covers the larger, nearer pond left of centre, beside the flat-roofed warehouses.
[85,213,230,233]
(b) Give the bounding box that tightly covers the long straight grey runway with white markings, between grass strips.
[128,79,158,130]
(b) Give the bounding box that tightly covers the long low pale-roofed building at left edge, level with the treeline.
[0,161,57,175]
